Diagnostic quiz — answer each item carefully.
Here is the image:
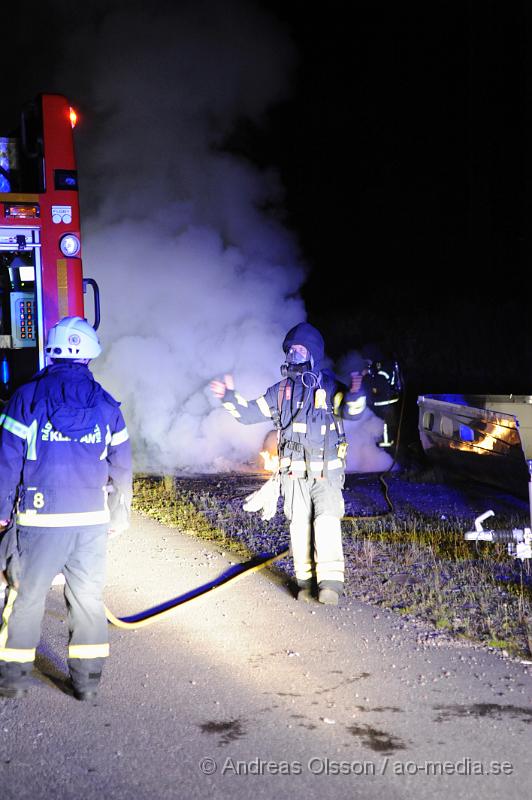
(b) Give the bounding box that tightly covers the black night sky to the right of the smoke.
[3,0,532,400]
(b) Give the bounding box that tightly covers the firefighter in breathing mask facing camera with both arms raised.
[210,322,365,605]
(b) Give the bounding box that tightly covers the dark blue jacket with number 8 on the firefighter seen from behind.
[0,363,132,527]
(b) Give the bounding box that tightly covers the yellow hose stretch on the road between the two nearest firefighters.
[105,547,290,630]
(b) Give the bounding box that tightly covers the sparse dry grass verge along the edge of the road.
[133,475,532,658]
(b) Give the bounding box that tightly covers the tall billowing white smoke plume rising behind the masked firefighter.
[56,0,392,471]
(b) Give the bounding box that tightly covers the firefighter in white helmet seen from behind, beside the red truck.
[0,317,132,700]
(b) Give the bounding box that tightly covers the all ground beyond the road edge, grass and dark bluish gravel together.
[136,472,532,657]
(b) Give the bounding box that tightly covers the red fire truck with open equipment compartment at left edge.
[0,94,100,400]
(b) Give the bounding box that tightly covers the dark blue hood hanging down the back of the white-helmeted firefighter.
[31,363,119,437]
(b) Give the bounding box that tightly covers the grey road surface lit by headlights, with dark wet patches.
[0,516,532,800]
